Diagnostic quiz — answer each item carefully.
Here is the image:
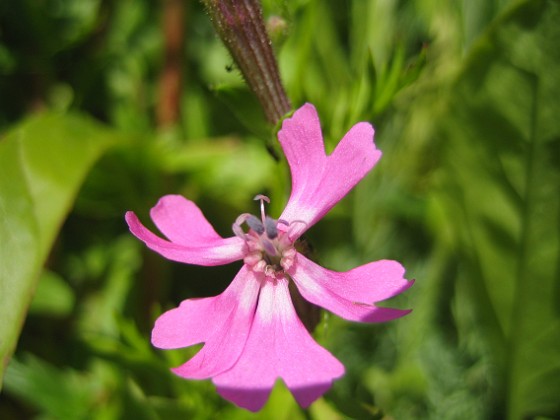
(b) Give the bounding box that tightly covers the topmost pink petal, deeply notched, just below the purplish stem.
[278,104,381,238]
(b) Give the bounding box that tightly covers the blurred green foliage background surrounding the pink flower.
[0,0,560,419]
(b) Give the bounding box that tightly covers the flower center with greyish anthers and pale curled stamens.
[233,195,296,278]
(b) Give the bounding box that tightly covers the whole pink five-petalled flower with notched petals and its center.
[126,104,412,411]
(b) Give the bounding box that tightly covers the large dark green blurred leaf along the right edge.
[444,0,560,419]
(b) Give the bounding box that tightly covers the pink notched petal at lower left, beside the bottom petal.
[152,266,260,379]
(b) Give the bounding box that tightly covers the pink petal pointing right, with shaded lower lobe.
[290,254,413,322]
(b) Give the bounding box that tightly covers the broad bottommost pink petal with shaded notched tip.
[213,279,344,411]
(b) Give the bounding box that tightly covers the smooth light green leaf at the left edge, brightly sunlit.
[0,114,120,388]
